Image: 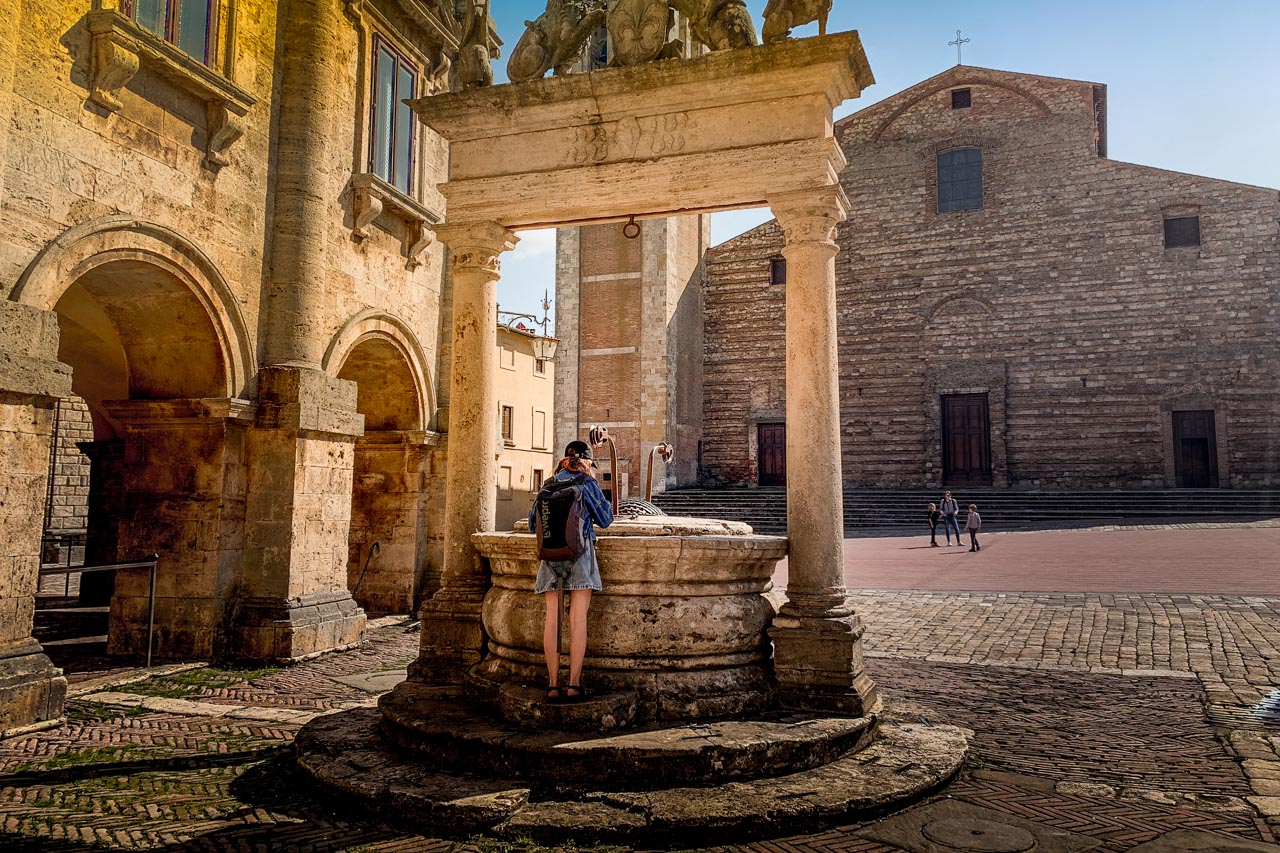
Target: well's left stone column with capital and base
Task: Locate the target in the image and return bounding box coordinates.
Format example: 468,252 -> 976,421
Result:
410,222 -> 518,683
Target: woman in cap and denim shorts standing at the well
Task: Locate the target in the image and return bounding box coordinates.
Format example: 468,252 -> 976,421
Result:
529,441 -> 613,702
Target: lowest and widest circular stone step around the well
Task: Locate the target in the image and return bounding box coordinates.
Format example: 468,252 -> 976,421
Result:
294,699 -> 968,847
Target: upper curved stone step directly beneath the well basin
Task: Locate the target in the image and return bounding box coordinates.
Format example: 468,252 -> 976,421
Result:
379,681 -> 873,790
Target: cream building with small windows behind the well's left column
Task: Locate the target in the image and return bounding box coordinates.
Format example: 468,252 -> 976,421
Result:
494,324 -> 559,530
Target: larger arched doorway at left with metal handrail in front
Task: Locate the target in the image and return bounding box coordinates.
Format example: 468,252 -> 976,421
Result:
13,219 -> 252,657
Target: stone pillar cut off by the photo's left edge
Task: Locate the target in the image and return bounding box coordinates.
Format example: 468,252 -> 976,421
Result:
0,298 -> 72,736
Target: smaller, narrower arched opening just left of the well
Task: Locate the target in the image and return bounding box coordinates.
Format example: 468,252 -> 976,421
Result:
338,333 -> 426,613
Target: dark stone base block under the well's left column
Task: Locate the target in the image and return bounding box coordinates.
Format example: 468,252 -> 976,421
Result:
408,593 -> 489,684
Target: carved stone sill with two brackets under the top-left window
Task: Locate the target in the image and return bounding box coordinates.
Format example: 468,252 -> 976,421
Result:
84,9 -> 257,172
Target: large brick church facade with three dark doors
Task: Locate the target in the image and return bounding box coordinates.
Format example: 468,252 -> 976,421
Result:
701,67 -> 1280,488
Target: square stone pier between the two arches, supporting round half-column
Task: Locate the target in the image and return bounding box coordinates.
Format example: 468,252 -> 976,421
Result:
235,368 -> 365,660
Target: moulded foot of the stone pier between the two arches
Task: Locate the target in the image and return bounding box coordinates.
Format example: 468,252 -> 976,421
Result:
228,590 -> 366,661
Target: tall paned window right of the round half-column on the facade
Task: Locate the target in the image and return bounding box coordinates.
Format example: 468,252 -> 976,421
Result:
369,35 -> 417,193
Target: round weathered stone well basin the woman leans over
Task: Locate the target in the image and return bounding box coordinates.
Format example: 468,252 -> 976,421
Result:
467,516 -> 787,722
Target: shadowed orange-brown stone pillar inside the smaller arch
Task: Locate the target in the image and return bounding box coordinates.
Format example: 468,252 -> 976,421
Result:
347,429 -> 434,613
